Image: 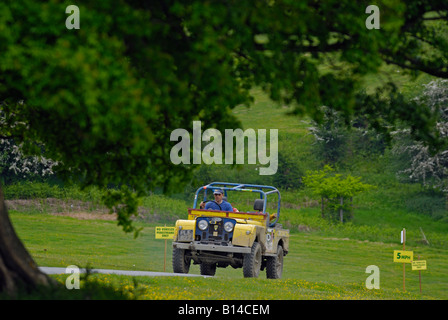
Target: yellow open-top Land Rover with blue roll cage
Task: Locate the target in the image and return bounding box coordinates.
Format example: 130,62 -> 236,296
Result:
173,182 -> 289,279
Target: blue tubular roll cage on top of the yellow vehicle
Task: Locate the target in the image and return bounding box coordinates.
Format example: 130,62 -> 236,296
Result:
193,182 -> 281,227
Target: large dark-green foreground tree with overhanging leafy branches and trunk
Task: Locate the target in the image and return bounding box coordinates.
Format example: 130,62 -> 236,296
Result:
0,0 -> 448,291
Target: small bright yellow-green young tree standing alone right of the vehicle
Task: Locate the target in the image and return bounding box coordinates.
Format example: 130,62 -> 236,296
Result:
303,165 -> 373,223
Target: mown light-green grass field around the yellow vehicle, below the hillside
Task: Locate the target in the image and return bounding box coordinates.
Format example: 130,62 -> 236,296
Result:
7,212 -> 448,300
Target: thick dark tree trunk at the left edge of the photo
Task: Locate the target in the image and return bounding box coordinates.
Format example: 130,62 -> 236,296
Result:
0,185 -> 51,295
